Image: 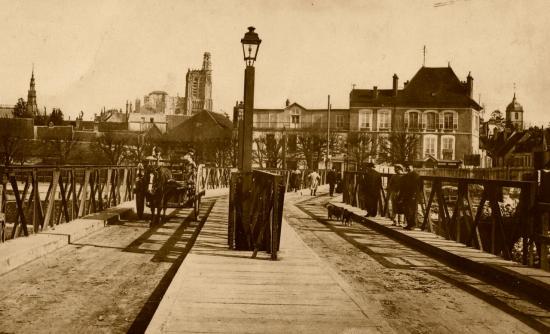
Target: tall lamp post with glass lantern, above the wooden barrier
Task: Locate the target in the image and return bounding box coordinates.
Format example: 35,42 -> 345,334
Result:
238,27 -> 262,173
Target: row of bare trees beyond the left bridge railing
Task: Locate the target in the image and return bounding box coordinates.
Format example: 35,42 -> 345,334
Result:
0,131 -> 234,167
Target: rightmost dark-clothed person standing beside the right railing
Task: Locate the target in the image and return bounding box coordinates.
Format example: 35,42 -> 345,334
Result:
399,164 -> 421,230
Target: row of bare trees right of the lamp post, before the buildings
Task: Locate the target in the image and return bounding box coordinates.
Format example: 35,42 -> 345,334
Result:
253,130 -> 419,169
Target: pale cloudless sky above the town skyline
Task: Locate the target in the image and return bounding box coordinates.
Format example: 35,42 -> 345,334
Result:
0,0 -> 550,125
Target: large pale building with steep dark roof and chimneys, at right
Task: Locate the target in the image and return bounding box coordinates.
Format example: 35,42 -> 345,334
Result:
349,67 -> 482,161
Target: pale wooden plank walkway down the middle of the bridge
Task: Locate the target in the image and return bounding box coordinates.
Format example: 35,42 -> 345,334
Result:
147,192 -> 391,333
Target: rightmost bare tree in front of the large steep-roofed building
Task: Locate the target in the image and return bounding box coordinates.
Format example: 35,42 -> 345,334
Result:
378,131 -> 418,164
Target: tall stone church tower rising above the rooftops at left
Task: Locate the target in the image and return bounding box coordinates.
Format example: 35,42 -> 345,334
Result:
183,52 -> 212,116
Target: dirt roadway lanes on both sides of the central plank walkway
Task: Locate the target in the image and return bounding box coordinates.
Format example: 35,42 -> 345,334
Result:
0,189 -> 550,333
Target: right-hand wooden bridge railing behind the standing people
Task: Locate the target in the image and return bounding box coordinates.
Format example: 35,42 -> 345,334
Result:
343,172 -> 548,265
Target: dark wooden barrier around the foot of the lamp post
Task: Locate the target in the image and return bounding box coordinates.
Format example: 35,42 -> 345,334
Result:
231,170 -> 285,260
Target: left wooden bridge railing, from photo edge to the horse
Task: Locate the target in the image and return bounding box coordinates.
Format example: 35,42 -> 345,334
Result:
0,166 -> 136,241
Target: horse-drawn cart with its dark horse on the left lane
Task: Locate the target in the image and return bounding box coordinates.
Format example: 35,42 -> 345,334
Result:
134,161 -> 205,225
